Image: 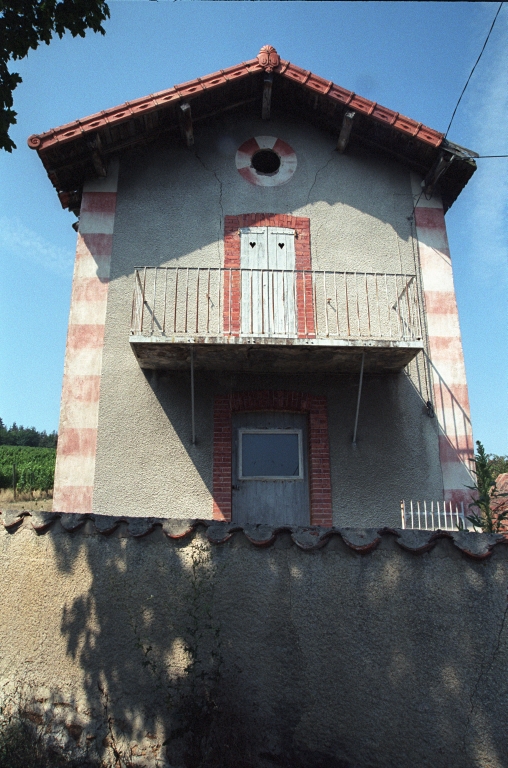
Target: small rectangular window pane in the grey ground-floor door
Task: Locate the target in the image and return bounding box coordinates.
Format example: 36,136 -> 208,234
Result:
238,429 -> 303,480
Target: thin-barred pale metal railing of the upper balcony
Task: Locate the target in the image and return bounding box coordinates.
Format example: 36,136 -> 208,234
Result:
131,267 -> 422,341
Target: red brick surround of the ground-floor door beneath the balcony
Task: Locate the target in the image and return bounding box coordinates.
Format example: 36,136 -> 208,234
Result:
213,390 -> 332,528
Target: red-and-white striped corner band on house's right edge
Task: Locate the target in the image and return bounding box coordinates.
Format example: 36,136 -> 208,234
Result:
412,174 -> 474,502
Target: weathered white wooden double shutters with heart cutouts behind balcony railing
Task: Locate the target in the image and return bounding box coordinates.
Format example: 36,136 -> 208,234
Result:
240,227 -> 296,336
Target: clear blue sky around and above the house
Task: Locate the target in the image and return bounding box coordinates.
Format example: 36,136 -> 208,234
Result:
0,0 -> 508,454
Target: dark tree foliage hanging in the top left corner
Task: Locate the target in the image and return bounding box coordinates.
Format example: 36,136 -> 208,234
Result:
0,0 -> 109,152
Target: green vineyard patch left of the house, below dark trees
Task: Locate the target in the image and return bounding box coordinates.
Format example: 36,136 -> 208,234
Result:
0,445 -> 56,492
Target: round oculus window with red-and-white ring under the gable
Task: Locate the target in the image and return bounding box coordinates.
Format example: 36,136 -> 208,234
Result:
236,136 -> 296,187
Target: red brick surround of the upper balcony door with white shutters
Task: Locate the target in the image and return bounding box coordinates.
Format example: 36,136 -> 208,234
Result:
223,213 -> 316,338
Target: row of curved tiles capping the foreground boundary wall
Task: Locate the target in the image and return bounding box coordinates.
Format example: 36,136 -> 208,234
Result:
0,511 -> 508,560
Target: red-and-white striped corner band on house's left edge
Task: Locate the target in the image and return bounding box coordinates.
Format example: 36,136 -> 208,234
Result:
53,161 -> 118,512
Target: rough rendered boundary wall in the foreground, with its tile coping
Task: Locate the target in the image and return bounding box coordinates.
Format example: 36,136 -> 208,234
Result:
0,513 -> 508,768
